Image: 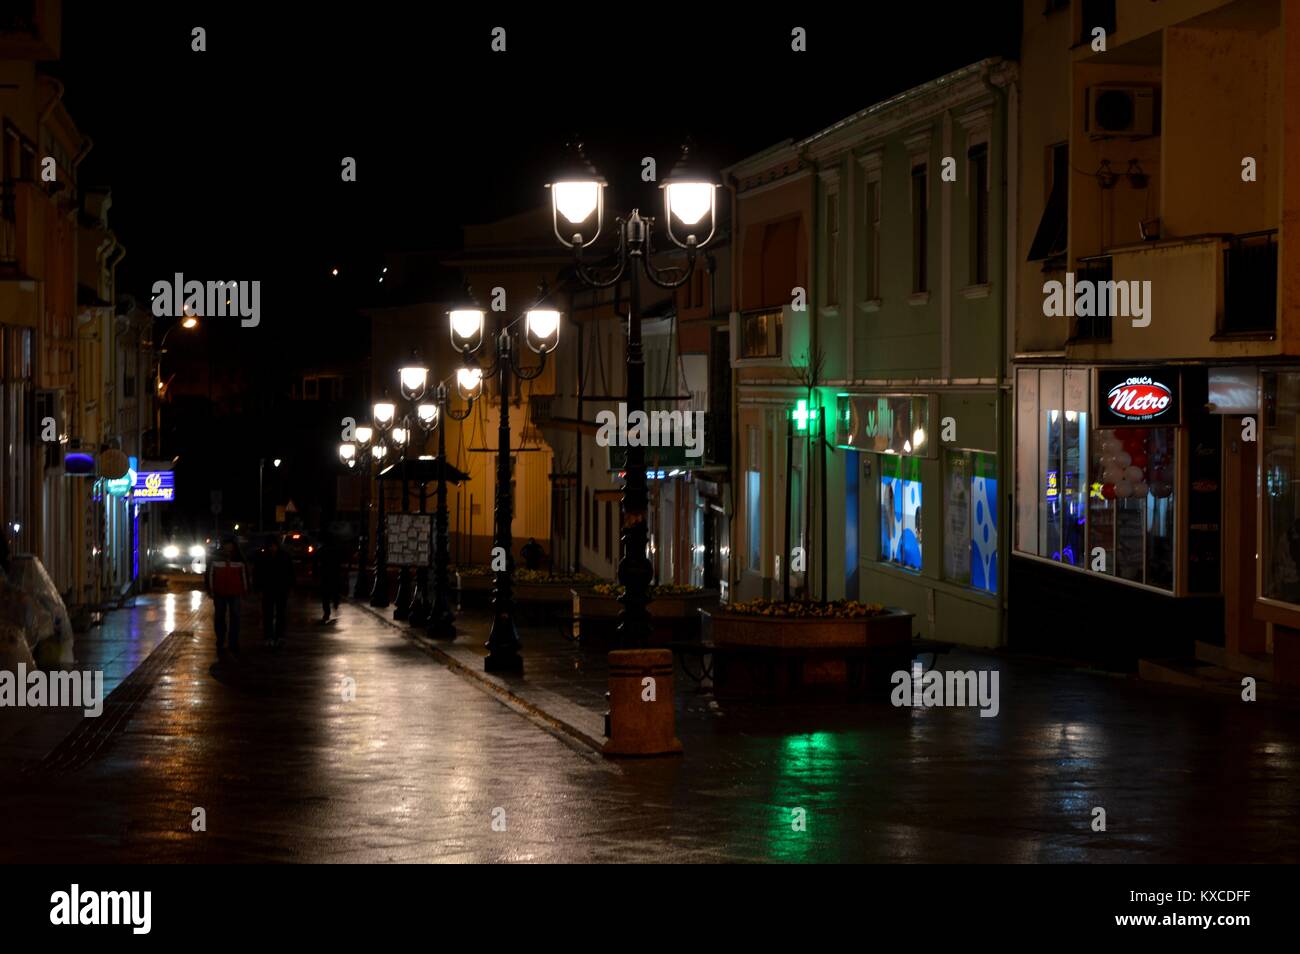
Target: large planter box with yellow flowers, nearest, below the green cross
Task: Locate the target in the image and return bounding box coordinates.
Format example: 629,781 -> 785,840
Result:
709,610 -> 913,702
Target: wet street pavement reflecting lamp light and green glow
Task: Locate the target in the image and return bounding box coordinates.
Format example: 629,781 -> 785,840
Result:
0,582 -> 1300,862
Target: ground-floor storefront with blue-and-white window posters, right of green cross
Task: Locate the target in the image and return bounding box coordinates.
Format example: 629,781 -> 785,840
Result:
832,387 -> 1006,646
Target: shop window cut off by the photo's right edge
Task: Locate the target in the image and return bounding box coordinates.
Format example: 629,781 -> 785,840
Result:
1261,372 -> 1300,603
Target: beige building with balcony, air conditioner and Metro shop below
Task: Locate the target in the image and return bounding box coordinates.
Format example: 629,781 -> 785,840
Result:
1010,0 -> 1300,681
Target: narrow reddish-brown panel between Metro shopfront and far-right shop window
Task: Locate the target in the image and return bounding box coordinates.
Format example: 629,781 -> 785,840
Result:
1223,415 -> 1265,652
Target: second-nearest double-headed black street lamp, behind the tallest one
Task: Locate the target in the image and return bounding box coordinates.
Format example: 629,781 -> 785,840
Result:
449,295 -> 560,673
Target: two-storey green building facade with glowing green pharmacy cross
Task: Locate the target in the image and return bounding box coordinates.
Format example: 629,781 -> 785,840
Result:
731,60 -> 1015,646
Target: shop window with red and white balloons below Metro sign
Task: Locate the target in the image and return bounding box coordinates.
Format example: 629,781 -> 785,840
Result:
1088,428 -> 1177,590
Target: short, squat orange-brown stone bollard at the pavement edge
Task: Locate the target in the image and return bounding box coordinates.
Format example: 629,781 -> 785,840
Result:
602,650 -> 681,755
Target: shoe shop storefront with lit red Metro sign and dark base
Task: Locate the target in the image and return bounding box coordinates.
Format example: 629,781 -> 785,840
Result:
1010,364 -> 1232,665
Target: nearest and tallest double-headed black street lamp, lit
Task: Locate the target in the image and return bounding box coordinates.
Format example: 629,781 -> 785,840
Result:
549,143 -> 719,646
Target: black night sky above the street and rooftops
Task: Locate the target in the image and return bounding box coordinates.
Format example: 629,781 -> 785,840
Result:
52,0 -> 1019,319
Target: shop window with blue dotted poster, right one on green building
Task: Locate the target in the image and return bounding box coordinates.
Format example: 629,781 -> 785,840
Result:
944,451 -> 997,593
